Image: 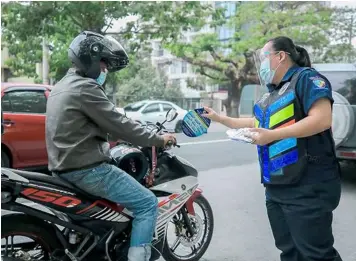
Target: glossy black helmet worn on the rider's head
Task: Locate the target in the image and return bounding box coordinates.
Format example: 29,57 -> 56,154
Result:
68,31 -> 129,79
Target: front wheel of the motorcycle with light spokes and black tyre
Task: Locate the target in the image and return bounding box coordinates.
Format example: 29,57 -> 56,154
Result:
162,195 -> 214,261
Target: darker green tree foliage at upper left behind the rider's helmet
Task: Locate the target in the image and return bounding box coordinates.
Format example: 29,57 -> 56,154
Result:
1,1 -> 209,80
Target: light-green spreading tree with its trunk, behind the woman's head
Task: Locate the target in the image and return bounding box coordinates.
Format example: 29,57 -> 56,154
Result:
165,2 -> 331,116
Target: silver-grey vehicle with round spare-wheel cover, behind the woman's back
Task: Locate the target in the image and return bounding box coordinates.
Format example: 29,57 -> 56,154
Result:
313,63 -> 356,163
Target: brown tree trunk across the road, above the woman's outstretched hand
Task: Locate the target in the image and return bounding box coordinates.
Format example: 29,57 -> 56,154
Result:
224,80 -> 242,118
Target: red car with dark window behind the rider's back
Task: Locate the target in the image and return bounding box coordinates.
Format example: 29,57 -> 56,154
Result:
1,83 -> 116,169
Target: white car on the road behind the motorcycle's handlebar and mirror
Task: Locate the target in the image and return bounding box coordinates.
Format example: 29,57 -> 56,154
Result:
116,100 -> 187,133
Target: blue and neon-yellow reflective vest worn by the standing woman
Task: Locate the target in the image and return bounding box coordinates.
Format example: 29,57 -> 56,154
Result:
254,68 -> 310,185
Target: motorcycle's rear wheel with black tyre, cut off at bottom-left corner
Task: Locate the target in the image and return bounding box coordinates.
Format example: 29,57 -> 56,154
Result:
1,213 -> 60,261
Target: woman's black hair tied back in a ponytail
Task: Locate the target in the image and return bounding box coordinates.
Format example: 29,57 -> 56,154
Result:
268,36 -> 311,67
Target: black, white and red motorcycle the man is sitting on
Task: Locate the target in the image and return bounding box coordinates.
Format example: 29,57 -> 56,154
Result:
1,109 -> 214,261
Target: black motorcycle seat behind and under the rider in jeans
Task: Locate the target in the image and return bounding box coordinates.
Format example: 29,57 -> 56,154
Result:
2,168 -> 100,199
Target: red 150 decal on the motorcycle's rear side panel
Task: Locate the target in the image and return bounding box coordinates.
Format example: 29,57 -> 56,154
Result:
21,188 -> 82,208
